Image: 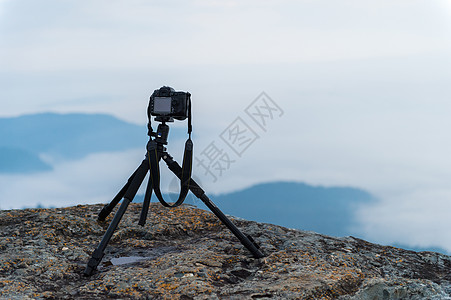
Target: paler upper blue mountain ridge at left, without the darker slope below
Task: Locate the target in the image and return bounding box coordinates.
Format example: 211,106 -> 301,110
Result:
0,113 -> 147,158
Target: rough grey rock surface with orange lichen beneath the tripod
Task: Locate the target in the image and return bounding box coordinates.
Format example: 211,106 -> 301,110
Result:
0,204 -> 451,299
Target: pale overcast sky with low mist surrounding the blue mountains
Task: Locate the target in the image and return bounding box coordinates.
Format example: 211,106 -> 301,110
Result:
0,0 -> 451,251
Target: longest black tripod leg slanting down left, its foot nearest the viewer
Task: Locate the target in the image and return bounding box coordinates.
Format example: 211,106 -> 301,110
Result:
84,160 -> 149,276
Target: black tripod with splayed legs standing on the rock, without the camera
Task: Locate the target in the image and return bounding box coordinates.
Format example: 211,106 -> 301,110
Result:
84,119 -> 264,276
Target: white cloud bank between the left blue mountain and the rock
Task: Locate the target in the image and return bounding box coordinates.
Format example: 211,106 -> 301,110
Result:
0,150 -> 144,209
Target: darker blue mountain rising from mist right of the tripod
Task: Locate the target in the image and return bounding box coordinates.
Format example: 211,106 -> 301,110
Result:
134,182 -> 375,236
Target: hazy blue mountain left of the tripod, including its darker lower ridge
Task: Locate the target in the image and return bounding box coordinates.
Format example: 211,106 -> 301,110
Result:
0,113 -> 182,173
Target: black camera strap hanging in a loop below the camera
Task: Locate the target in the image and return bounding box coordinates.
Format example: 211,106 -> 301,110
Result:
147,100 -> 193,207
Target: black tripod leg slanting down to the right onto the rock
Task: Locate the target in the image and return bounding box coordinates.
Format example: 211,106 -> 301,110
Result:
163,153 -> 265,258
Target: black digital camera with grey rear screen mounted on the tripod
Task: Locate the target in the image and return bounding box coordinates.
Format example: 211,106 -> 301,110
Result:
148,86 -> 191,120
